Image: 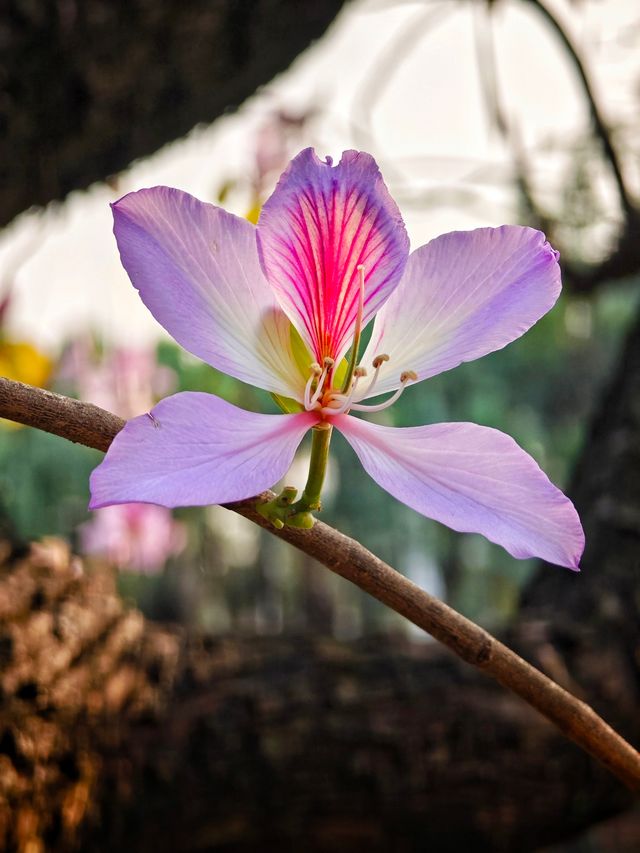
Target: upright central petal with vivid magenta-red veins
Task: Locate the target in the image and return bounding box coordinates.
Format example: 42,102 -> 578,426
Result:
258,148 -> 409,363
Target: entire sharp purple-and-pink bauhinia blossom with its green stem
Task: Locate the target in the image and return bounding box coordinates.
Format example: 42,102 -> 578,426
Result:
91,149 -> 584,569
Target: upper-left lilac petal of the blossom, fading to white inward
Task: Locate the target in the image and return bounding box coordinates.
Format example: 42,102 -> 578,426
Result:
112,187 -> 306,399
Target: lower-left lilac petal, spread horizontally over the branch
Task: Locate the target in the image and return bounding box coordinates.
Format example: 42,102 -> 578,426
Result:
89,391 -> 317,509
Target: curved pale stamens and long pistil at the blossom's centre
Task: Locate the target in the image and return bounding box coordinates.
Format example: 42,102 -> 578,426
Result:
304,266 -> 418,419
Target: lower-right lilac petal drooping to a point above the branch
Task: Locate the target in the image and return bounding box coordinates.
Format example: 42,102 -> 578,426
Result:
333,415 -> 584,570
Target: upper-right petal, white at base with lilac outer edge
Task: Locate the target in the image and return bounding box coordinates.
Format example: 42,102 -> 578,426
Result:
362,225 -> 561,395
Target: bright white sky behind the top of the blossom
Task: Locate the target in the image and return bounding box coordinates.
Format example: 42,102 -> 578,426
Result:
0,0 -> 640,351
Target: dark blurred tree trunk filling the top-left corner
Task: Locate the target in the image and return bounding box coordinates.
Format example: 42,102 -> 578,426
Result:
0,0 -> 343,227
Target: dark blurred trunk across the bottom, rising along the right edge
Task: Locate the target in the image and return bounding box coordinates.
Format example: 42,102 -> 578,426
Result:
0,308 -> 640,853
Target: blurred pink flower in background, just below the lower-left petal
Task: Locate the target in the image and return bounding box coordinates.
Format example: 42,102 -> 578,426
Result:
79,504 -> 187,574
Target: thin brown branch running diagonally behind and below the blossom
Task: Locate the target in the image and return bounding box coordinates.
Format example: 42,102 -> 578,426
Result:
0,379 -> 640,791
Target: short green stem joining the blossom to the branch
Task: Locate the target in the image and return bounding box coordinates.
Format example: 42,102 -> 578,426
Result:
256,421 -> 333,530
